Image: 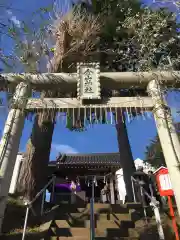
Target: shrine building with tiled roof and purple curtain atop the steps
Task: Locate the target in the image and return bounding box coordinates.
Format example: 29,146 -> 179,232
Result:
48,153 -> 121,204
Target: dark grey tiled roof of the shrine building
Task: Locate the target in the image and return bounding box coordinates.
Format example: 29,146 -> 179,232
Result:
57,153 -> 120,167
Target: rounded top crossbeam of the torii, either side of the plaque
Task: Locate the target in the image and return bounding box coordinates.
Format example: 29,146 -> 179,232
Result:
0,71 -> 180,92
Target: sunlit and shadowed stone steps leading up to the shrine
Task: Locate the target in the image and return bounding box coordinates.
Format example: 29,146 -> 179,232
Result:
41,203 -> 148,240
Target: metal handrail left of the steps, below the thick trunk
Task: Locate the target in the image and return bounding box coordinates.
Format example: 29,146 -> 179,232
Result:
22,175 -> 56,240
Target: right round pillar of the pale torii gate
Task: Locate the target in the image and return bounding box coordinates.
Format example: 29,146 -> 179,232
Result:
147,80 -> 180,215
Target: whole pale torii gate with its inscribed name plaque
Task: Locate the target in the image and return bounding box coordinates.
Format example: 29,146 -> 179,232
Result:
0,63 -> 180,231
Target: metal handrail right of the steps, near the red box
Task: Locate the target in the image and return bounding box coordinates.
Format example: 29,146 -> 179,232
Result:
131,176 -> 165,240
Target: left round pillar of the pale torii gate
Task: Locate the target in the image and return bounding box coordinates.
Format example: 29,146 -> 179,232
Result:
0,82 -> 30,232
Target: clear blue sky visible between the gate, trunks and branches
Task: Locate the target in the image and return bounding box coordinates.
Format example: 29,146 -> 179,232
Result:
0,0 -> 180,160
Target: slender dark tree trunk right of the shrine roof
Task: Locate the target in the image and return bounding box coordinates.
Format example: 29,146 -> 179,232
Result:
116,109 -> 136,202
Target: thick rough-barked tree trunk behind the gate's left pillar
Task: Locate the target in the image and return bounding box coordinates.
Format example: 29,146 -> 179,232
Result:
18,112 -> 55,201
